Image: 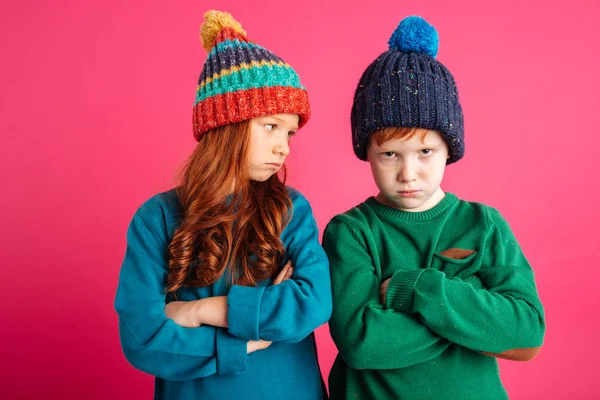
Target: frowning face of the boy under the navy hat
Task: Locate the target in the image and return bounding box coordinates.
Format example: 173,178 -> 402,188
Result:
367,129 -> 448,211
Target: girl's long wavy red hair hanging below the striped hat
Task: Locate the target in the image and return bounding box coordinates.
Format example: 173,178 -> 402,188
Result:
167,121 -> 292,293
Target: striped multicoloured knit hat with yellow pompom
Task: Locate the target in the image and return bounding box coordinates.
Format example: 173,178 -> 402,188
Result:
193,11 -> 310,140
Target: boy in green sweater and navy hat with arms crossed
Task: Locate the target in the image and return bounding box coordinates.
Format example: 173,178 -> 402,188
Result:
323,17 -> 545,400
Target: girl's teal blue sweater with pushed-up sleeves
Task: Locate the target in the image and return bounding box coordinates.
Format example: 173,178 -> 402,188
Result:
115,189 -> 331,400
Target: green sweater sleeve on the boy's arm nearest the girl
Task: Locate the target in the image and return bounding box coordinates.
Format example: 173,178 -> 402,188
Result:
323,218 -> 449,369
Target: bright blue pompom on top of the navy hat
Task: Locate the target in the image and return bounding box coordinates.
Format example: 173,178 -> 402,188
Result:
388,16 -> 440,58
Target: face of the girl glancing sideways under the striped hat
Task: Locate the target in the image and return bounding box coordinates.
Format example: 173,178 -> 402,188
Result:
248,114 -> 299,182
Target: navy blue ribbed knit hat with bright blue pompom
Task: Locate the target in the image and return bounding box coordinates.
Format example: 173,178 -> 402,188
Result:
351,16 -> 465,164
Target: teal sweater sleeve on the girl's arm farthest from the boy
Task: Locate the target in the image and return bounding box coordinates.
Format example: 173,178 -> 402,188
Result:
115,199 -> 247,380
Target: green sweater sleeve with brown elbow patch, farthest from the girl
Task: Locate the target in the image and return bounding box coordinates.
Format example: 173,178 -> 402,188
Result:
387,209 -> 545,360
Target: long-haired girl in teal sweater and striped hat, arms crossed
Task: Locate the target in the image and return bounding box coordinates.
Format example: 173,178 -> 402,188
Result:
115,11 -> 331,400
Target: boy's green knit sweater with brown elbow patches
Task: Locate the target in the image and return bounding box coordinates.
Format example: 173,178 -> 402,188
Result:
323,193 -> 545,400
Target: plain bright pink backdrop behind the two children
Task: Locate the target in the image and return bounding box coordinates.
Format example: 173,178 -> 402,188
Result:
0,0 -> 600,400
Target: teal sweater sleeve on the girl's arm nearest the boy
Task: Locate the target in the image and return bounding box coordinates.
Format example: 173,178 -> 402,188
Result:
227,192 -> 331,343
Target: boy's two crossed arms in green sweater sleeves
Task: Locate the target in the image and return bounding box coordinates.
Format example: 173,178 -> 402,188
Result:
323,217 -> 545,369
